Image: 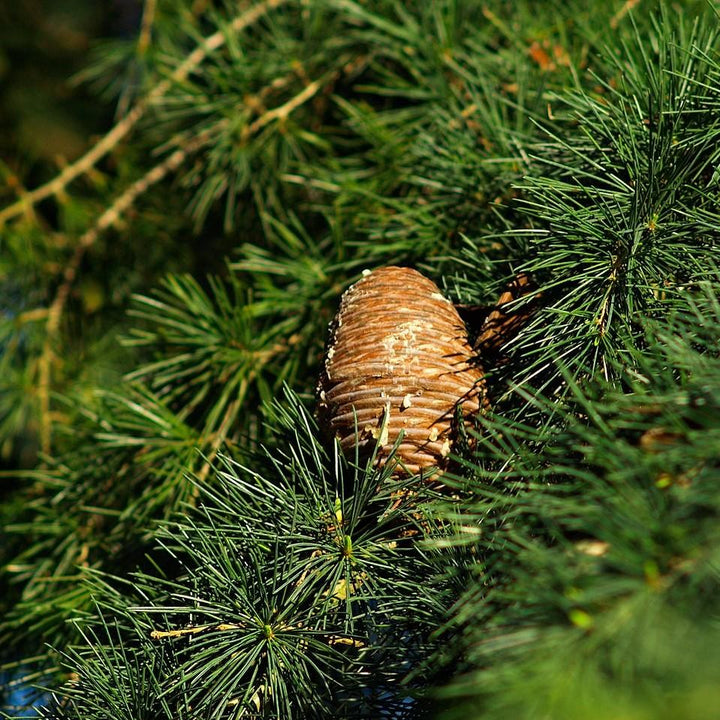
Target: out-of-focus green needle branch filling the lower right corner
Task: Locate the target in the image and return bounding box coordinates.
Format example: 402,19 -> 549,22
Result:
434,281 -> 720,719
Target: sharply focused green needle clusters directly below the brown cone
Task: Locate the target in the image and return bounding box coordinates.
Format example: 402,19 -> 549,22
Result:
35,396 -> 456,718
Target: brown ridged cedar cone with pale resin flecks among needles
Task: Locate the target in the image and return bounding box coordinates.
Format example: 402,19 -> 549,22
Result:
318,267 -> 486,474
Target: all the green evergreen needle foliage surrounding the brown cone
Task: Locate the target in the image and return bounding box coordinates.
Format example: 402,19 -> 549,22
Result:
0,0 -> 720,720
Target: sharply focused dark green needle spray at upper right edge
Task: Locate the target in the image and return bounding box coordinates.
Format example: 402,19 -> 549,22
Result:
500,8 -> 720,386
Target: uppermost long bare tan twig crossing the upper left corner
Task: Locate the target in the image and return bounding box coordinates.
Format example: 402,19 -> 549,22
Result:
0,0 -> 288,226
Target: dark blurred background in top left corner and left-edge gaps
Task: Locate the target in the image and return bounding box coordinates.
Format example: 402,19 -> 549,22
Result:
0,0 -> 132,716
